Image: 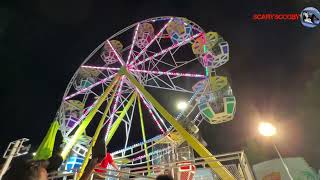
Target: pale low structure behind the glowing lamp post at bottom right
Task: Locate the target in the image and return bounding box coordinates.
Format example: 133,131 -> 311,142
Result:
253,157 -> 320,180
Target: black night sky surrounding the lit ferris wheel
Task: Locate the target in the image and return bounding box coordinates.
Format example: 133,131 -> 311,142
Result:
0,0 -> 320,168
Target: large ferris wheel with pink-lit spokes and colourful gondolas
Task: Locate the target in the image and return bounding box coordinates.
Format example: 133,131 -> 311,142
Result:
50,17 -> 236,179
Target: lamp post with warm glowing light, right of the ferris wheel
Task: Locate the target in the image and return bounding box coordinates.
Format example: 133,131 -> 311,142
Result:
259,122 -> 293,180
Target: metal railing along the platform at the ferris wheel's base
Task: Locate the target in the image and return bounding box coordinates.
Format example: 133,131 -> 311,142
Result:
49,151 -> 254,180
